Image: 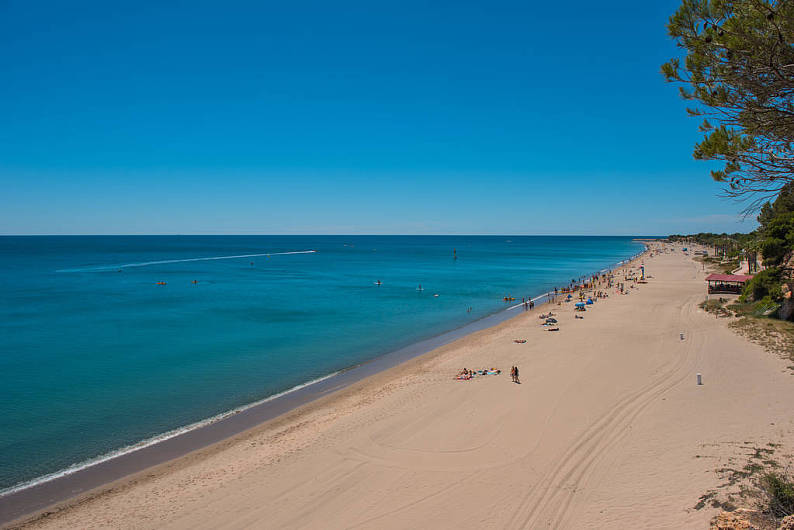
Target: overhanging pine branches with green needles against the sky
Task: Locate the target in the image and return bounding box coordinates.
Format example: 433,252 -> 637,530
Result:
662,0 -> 794,204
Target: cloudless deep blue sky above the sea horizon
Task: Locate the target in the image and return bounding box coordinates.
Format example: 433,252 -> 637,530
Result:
0,0 -> 756,235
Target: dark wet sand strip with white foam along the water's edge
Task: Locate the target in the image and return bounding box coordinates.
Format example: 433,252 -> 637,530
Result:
0,245 -> 657,527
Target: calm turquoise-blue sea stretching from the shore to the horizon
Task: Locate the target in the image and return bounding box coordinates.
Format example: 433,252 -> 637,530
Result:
0,236 -> 643,490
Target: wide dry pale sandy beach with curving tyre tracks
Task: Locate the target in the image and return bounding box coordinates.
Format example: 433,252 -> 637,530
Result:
6,244 -> 794,528
